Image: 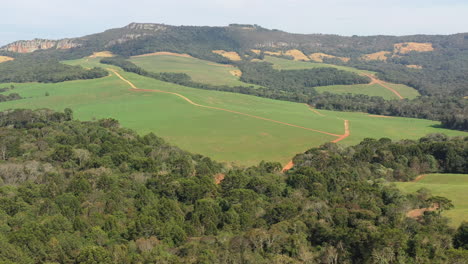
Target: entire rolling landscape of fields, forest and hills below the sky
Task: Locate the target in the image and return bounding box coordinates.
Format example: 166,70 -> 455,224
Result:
0,23 -> 468,264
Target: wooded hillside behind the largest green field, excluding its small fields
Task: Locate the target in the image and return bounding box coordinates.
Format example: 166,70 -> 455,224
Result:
0,23 -> 468,130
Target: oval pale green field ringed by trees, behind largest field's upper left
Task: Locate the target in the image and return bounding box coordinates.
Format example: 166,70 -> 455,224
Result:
130,55 -> 253,87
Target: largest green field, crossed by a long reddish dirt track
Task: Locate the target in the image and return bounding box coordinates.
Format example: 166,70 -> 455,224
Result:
0,59 -> 468,165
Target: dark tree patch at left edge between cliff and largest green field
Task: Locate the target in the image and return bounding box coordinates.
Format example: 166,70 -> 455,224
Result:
0,56 -> 107,83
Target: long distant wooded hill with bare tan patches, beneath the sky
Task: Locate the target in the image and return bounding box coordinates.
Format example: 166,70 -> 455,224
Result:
0,23 -> 468,96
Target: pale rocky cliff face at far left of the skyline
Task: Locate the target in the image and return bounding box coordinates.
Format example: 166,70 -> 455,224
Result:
0,39 -> 80,53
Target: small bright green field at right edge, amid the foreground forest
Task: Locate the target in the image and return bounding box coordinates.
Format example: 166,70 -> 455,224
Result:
396,174 -> 468,227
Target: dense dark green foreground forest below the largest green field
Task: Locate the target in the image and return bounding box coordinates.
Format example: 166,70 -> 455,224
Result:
0,109 -> 468,263
